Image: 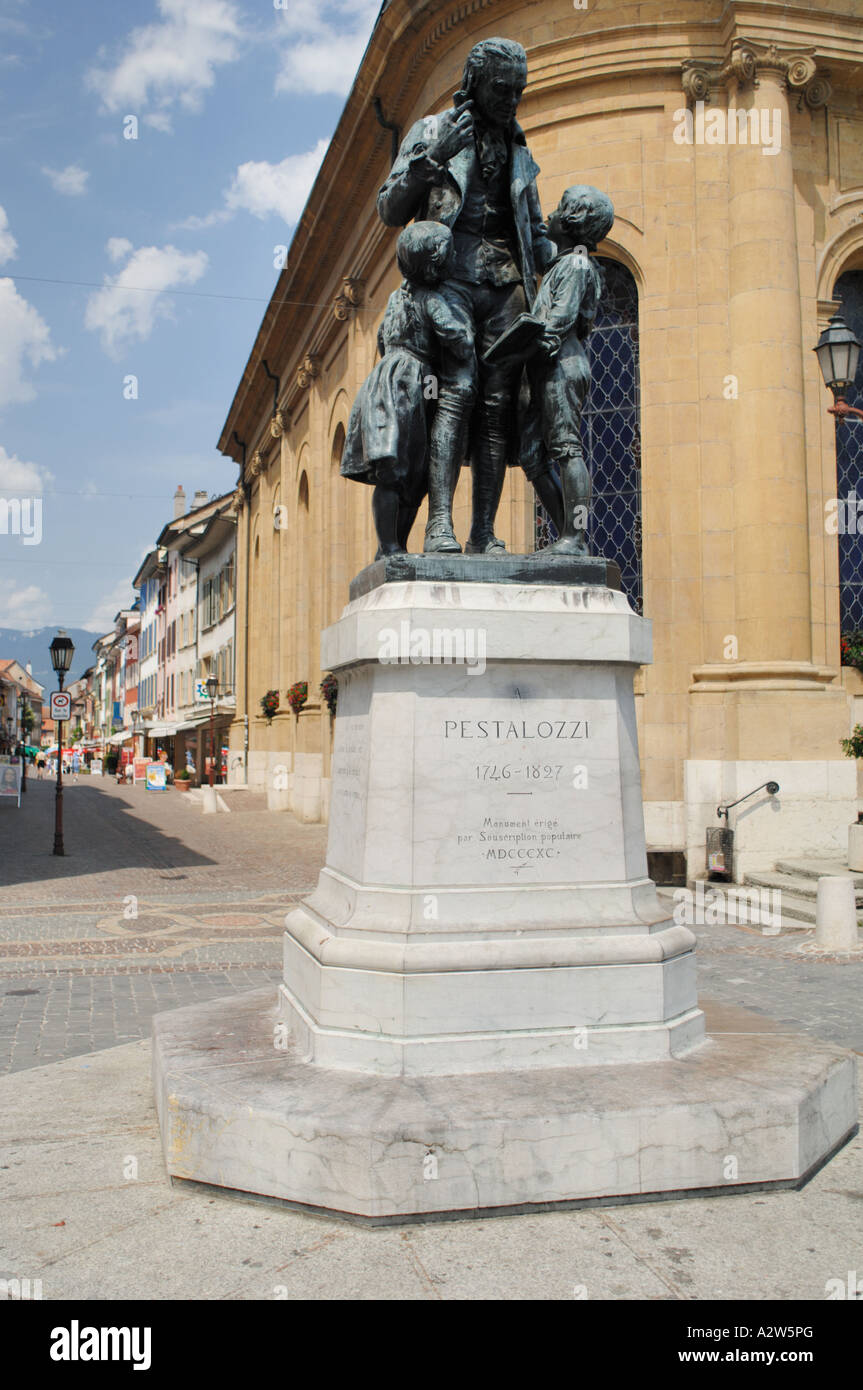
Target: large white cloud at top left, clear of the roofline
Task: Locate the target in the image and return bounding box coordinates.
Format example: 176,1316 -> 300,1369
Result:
86,0 -> 242,129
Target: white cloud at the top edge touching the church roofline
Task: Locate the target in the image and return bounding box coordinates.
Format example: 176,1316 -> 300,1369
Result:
275,0 -> 381,96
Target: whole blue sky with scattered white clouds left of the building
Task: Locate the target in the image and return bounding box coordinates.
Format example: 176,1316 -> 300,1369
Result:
0,0 -> 381,636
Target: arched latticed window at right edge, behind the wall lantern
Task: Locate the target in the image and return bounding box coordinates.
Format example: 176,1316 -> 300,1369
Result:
832,270 -> 863,635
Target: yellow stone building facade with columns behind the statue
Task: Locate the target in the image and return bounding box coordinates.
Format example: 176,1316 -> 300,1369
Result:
220,0 -> 863,873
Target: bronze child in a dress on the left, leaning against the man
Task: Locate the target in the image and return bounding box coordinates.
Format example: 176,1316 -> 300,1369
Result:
340,222 -> 475,555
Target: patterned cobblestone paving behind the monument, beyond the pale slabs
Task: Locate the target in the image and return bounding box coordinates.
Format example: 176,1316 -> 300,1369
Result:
0,778 -> 863,1072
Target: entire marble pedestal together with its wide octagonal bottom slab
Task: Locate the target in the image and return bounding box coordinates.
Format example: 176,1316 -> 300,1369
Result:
154,557 -> 856,1220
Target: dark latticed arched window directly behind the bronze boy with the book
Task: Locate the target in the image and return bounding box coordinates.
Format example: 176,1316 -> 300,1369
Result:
536,256 -> 643,613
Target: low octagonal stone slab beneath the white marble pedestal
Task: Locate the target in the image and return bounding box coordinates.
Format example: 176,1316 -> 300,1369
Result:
153,990 -> 856,1223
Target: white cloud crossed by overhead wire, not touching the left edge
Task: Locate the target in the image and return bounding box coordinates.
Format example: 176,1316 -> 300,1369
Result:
83,236 -> 208,357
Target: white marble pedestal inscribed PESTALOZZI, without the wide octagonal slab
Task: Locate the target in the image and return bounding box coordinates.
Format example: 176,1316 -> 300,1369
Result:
281,575 -> 705,1076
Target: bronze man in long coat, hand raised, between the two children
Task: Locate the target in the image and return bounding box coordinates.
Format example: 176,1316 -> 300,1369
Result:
378,39 -> 554,555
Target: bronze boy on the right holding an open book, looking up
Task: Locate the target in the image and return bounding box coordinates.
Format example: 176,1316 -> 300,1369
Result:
520,185 -> 614,555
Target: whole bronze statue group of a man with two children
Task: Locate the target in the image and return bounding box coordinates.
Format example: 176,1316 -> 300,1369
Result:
342,39 -> 614,557
